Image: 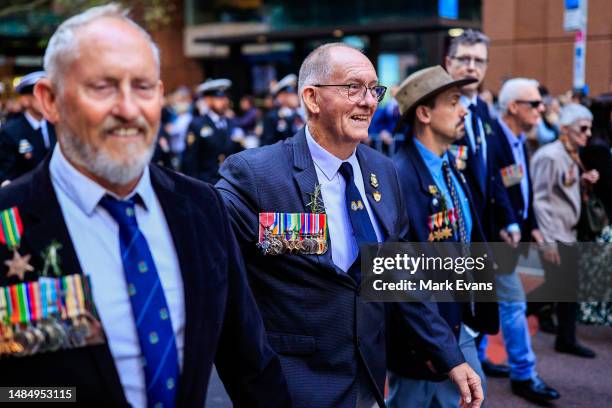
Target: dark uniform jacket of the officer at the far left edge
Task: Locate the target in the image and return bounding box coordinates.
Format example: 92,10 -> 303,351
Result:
0,114 -> 55,182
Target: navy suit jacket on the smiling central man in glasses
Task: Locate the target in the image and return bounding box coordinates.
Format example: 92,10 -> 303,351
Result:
217,130 -> 464,408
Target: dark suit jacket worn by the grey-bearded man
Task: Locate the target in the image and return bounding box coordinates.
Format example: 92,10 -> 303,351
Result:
0,160 -> 290,407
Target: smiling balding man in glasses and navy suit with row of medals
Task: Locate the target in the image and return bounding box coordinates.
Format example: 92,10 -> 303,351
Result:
217,43 -> 482,408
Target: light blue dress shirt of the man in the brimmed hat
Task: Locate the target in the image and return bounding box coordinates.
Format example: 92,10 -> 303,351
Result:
414,138 -> 472,242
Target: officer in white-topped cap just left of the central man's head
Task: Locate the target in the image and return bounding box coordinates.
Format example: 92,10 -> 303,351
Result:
261,74 -> 304,146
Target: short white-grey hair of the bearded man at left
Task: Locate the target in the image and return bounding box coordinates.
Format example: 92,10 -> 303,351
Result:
44,3 -> 160,89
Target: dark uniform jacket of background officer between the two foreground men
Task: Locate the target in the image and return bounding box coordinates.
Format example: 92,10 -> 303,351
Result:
181,115 -> 242,184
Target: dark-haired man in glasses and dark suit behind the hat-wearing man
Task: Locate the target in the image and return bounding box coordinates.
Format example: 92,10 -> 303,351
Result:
446,29 -> 521,377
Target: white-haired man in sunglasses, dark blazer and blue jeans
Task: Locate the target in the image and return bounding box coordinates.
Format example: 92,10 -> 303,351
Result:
480,78 -> 559,403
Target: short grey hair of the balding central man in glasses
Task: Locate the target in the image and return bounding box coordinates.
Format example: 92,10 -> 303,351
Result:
298,42 -> 362,116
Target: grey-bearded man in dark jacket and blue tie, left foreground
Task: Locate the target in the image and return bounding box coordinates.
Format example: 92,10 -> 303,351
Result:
0,4 -> 290,407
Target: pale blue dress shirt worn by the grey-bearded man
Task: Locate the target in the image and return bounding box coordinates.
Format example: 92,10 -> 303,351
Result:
50,144 -> 185,407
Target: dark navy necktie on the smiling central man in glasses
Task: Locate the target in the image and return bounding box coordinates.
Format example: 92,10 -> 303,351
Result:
339,162 -> 378,284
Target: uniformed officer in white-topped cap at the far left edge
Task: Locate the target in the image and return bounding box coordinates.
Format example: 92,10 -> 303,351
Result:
0,71 -> 55,183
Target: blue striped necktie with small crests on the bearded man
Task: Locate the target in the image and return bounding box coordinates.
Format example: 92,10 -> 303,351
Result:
100,196 -> 179,408
